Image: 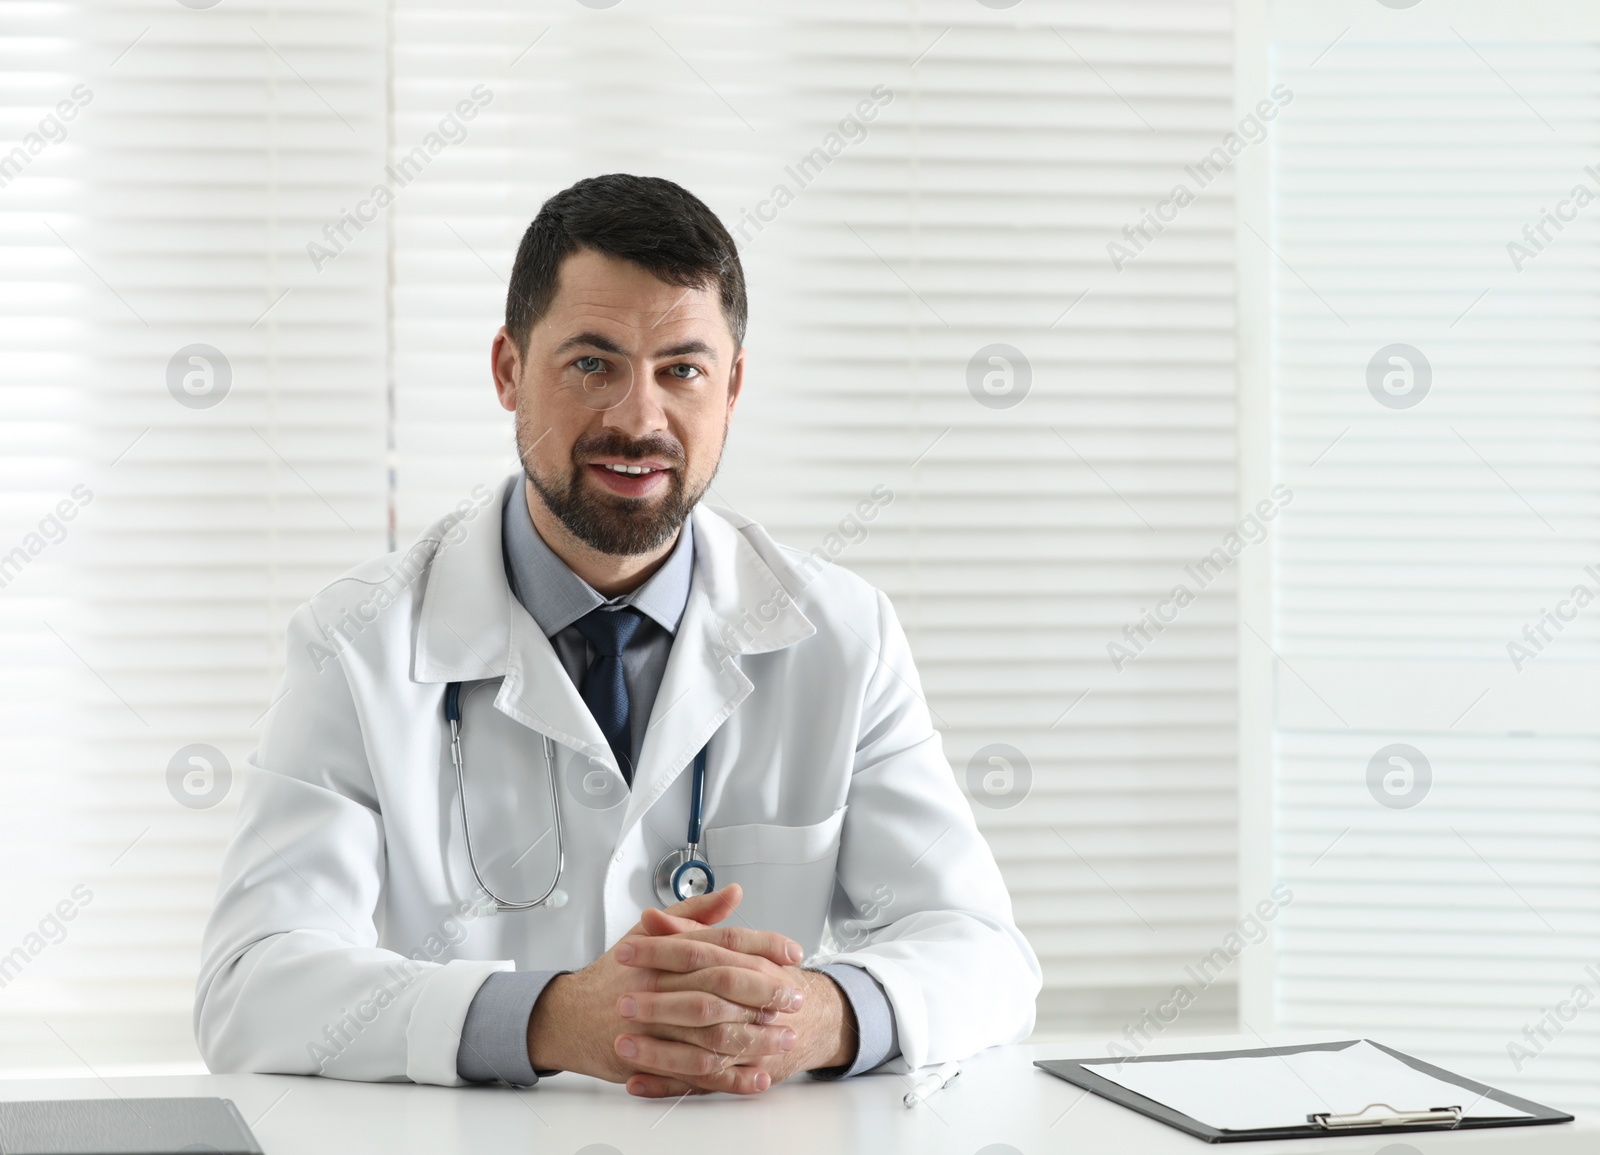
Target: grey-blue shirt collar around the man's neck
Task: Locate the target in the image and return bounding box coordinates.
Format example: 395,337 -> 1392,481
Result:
501,478 -> 694,638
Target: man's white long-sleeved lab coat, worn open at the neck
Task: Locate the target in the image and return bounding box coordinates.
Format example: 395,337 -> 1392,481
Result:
195,474 -> 1040,1085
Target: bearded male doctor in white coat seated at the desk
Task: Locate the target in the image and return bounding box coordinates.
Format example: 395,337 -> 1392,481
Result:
195,174 -> 1040,1096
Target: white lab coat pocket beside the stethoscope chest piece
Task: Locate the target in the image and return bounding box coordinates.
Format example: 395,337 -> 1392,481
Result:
706,806 -> 848,957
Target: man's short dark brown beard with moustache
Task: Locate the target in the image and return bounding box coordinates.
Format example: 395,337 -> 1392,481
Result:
517,419 -> 728,557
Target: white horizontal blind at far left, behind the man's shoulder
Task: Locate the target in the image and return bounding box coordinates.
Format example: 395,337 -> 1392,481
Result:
0,0 -> 386,1073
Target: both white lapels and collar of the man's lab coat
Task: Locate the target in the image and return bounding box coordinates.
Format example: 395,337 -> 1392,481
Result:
411,472 -> 816,796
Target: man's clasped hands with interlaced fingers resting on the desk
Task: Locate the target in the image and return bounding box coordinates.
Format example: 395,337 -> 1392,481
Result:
528,885 -> 854,1097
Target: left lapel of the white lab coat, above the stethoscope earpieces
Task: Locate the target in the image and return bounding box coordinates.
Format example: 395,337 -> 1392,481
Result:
406,474 -> 616,769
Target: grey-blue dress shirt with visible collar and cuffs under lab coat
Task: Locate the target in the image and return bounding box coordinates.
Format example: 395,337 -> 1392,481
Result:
456,482 -> 899,1086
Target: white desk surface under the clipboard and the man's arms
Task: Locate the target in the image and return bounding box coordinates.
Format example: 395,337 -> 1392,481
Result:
0,1038 -> 1600,1155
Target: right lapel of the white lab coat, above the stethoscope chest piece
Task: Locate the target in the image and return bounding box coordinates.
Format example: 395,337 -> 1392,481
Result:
622,507 -> 816,837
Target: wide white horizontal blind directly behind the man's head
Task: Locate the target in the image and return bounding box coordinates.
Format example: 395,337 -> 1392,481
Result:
395,0 -> 1237,1038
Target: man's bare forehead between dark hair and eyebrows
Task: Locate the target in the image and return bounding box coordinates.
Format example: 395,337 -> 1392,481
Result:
533,248 -> 733,344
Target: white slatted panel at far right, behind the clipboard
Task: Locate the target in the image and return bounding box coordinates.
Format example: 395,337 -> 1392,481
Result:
1258,15 -> 1600,1107
